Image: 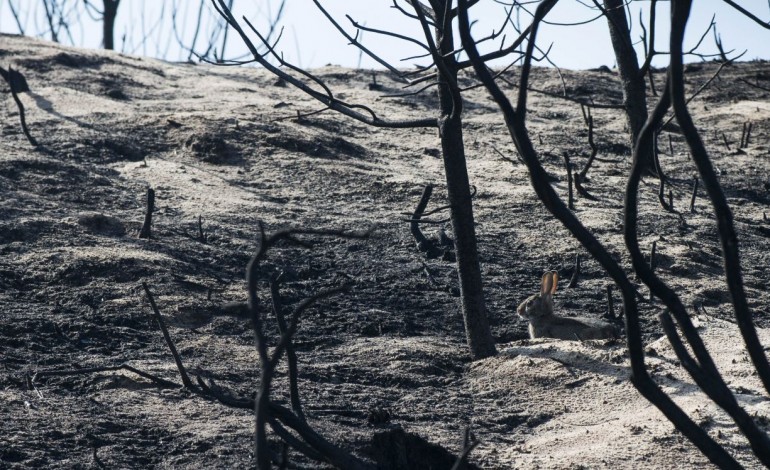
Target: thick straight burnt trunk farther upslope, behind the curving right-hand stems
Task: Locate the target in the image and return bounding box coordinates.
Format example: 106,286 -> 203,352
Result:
604,0 -> 647,154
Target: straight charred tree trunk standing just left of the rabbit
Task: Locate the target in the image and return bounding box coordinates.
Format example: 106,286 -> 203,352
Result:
431,0 -> 497,359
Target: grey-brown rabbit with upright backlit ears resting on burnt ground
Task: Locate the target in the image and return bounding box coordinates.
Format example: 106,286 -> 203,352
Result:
517,271 -> 618,341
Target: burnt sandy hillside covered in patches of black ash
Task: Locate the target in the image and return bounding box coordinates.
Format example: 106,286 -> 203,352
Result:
0,36 -> 770,469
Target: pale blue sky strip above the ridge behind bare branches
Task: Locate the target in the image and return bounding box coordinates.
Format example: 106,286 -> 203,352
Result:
0,0 -> 770,69
